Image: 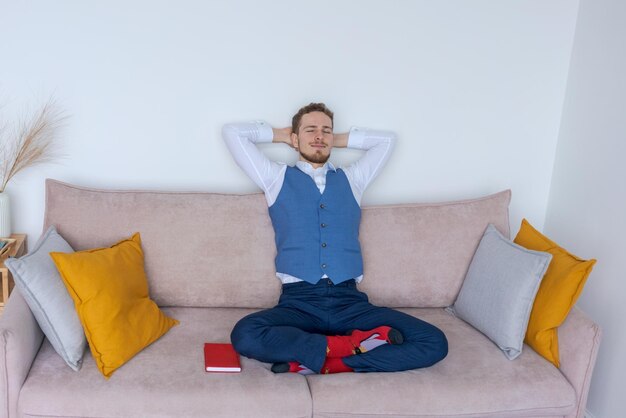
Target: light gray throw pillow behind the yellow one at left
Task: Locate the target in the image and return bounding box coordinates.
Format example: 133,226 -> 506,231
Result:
4,226 -> 87,371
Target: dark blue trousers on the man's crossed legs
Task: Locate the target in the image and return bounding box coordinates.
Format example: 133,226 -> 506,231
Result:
231,279 -> 448,373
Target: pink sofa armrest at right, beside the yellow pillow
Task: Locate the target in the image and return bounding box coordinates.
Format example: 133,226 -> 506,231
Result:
558,306 -> 602,418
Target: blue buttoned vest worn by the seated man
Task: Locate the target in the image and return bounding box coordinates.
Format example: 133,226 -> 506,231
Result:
269,167 -> 363,284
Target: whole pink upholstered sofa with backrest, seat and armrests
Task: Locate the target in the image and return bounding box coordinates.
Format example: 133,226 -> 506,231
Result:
0,180 -> 600,418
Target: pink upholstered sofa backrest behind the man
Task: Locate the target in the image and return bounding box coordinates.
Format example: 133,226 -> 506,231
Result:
44,180 -> 510,308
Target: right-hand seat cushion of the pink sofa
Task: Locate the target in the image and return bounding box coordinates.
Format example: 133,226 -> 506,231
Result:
307,309 -> 576,418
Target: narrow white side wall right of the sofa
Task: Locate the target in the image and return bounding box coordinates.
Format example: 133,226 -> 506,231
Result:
545,0 -> 626,418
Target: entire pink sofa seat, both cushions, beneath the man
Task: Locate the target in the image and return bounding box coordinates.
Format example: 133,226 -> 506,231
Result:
18,308 -> 576,418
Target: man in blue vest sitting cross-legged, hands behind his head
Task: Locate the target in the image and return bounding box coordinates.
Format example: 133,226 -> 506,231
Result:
222,103 -> 448,374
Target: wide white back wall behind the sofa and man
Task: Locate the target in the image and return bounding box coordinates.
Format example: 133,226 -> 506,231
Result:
0,0 -> 578,242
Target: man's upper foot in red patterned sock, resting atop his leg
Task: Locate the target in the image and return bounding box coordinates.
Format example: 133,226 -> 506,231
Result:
326,326 -> 404,358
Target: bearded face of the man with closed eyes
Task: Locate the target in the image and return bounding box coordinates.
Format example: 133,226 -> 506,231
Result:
291,112 -> 334,168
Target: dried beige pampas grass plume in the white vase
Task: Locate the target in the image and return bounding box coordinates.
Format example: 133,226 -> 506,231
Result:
0,99 -> 67,193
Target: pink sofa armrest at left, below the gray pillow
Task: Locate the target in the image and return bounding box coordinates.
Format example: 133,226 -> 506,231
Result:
0,291 -> 43,417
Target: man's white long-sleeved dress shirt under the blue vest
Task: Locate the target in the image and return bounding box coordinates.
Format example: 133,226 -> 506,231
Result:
222,121 -> 396,283
